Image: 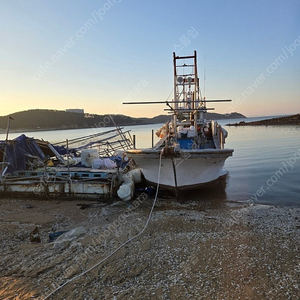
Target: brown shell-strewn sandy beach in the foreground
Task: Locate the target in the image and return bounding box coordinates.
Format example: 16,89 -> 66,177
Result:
0,197 -> 300,300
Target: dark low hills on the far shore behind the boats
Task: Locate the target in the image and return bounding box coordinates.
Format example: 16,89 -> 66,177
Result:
0,109 -> 245,131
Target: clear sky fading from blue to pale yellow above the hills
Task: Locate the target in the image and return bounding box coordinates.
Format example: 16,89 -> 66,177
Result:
0,0 -> 300,117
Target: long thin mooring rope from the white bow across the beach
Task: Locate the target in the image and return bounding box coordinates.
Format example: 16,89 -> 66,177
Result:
43,149 -> 163,300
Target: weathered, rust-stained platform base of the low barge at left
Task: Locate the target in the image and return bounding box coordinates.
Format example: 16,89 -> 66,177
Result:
0,167 -> 121,198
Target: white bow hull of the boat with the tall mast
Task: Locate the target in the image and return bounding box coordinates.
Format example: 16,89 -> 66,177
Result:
127,149 -> 233,188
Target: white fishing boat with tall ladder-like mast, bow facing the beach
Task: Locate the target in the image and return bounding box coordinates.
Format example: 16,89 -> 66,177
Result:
124,51 -> 234,192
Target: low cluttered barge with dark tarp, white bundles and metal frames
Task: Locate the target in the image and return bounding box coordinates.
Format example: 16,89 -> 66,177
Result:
0,126 -> 136,199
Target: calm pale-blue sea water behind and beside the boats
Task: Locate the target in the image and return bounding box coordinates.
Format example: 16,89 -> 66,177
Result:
0,117 -> 300,206
